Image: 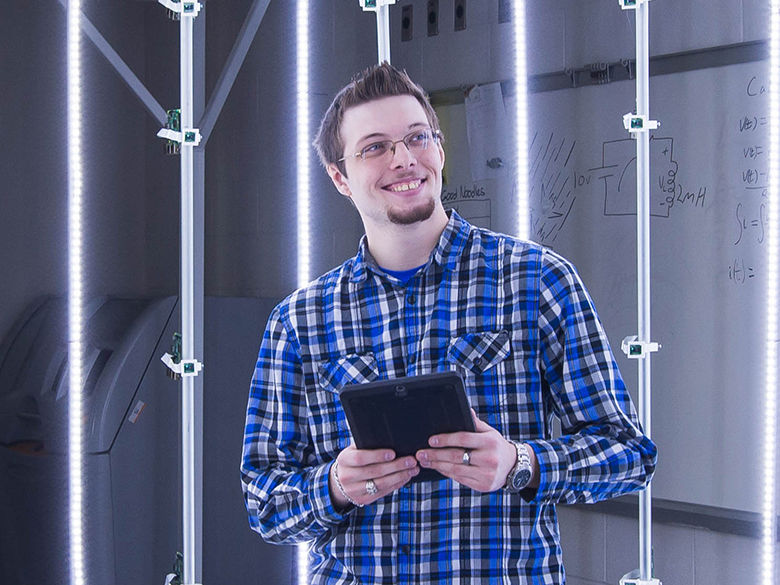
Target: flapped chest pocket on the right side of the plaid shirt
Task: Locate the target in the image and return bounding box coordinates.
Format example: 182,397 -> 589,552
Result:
447,330 -> 512,428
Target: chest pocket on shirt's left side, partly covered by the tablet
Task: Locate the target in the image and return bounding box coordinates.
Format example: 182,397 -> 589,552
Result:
314,353 -> 379,455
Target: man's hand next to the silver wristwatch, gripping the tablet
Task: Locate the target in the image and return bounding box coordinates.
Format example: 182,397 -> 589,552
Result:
415,409 -> 517,492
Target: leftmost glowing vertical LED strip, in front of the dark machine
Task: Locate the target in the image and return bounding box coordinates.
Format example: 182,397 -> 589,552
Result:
67,0 -> 86,585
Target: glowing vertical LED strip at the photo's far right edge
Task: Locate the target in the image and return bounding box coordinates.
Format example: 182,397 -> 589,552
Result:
761,0 -> 780,585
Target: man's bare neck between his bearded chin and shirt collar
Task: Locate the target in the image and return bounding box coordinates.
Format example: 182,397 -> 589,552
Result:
365,204 -> 449,270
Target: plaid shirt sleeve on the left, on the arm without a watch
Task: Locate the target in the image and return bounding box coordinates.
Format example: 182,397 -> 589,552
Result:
241,307 -> 345,544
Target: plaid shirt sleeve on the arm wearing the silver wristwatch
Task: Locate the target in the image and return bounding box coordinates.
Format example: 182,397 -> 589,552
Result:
529,251 -> 657,503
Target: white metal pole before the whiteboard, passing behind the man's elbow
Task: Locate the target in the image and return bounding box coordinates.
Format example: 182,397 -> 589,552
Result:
635,2 -> 653,581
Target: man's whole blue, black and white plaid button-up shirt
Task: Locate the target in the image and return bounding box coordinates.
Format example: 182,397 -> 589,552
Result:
241,211 -> 656,585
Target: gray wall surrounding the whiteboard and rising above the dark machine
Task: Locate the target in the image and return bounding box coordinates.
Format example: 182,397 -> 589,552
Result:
0,0 -> 768,585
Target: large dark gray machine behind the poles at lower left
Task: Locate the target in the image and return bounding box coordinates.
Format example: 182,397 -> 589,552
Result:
0,297 -> 294,585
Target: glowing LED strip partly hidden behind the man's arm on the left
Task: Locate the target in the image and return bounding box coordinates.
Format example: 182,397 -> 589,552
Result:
295,0 -> 311,585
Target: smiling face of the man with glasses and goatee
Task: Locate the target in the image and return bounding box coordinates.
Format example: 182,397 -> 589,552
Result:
328,95 -> 444,230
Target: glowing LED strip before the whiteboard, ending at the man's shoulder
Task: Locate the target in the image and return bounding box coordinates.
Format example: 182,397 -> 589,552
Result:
512,0 -> 530,239
